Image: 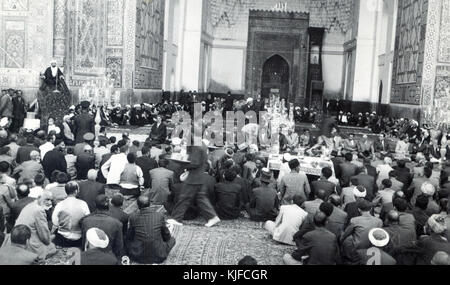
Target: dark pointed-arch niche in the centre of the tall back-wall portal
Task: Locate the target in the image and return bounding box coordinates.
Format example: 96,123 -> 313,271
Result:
261,54 -> 290,102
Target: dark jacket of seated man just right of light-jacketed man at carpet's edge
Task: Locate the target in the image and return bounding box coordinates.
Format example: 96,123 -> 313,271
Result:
292,228 -> 338,265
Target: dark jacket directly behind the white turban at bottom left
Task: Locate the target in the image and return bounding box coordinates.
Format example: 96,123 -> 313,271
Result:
81,211 -> 124,258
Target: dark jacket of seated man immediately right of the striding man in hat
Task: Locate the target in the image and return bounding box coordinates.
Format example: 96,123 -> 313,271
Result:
215,182 -> 241,220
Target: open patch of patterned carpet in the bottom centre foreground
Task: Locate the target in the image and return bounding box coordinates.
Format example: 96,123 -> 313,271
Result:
165,220 -> 294,265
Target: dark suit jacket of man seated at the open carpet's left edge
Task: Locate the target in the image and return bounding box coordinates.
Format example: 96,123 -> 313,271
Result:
127,205 -> 175,264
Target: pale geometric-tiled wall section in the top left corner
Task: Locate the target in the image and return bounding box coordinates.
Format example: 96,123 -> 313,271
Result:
0,0 -> 54,89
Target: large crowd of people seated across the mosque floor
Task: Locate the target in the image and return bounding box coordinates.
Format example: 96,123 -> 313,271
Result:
0,90 -> 450,265
